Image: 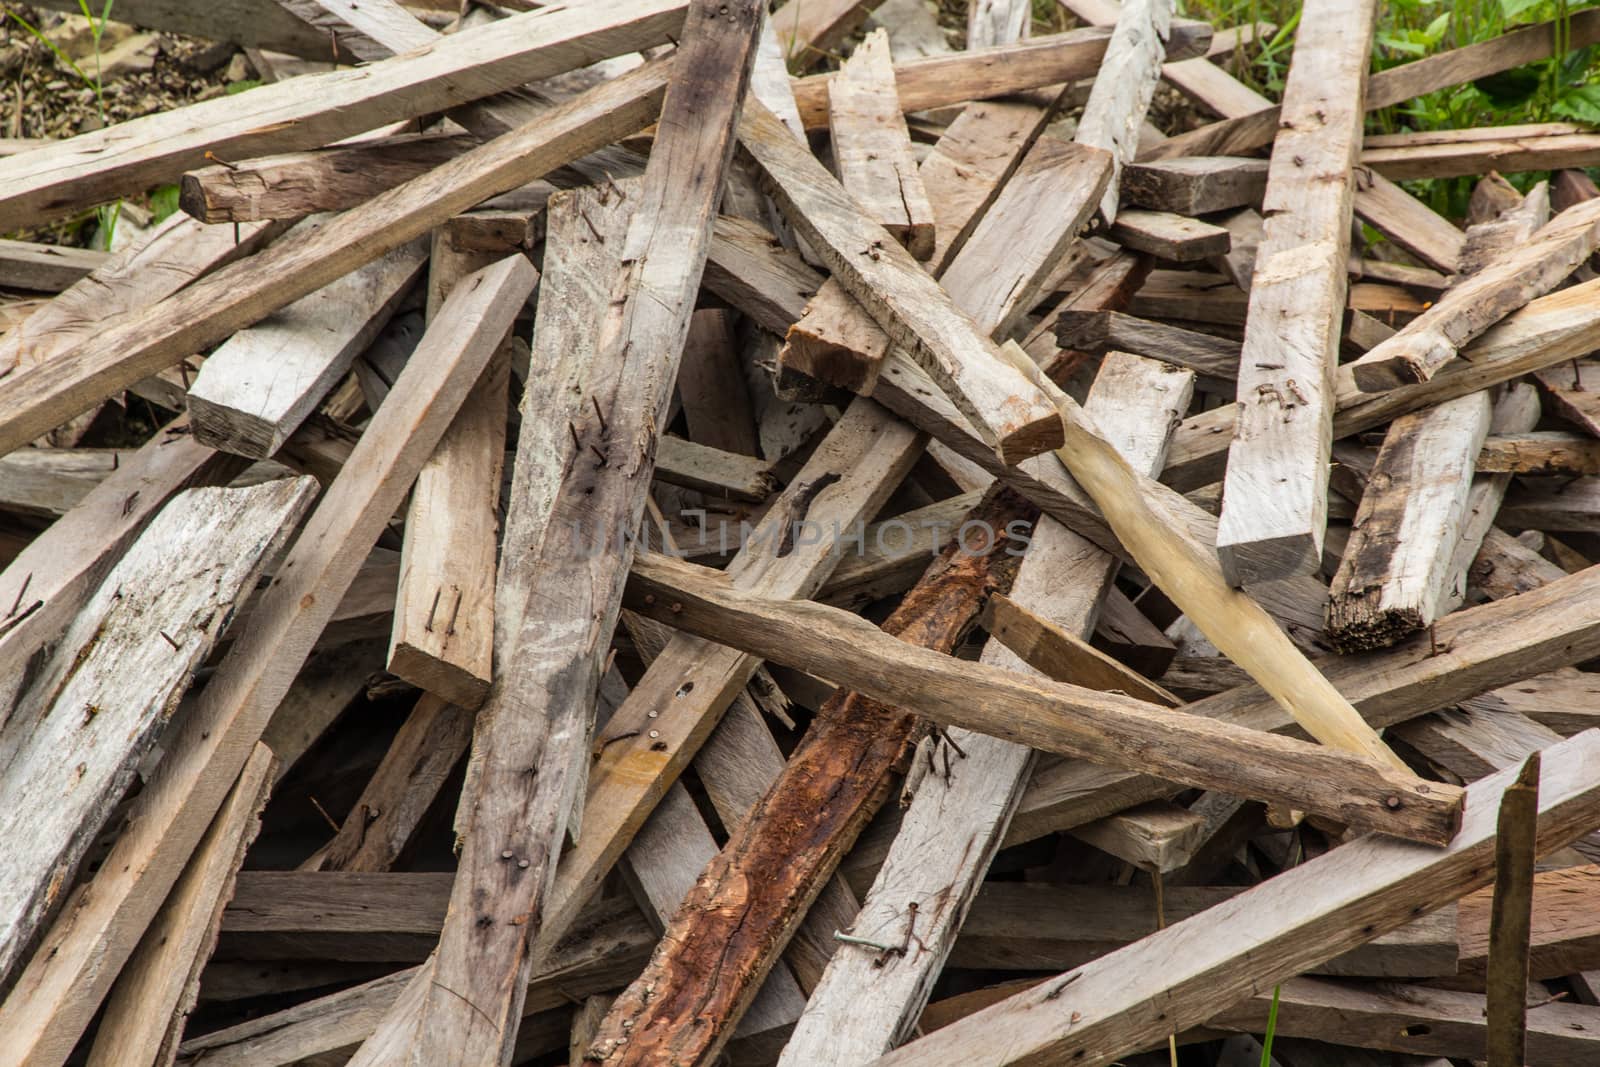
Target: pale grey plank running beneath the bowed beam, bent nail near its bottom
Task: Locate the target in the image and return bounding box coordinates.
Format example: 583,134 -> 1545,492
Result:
779,357 -> 1192,1067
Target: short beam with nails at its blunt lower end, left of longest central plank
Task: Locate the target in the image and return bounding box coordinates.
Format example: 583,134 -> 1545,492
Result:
389,232 -> 510,710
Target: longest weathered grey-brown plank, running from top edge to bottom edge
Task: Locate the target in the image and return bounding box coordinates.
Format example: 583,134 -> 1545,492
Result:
354,2 -> 758,1064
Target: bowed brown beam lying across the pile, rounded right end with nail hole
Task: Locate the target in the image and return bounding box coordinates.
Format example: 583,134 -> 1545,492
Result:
627,557 -> 1459,841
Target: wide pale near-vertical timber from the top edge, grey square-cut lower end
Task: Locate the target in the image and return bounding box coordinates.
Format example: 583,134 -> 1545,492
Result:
1216,0 -> 1376,585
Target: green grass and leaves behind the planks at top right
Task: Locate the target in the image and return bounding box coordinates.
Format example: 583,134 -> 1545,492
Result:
1176,0 -> 1600,218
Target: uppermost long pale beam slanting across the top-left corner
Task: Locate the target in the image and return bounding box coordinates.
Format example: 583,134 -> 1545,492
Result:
0,0 -> 686,230
